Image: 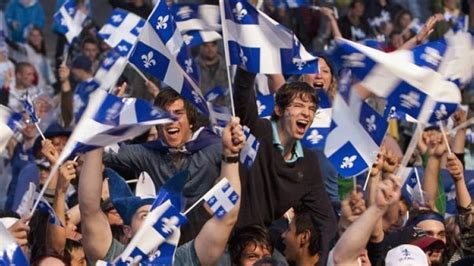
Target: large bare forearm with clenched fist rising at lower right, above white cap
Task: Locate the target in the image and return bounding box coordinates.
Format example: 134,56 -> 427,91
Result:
333,175 -> 400,265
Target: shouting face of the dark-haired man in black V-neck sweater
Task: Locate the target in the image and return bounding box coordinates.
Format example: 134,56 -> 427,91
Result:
275,94 -> 317,144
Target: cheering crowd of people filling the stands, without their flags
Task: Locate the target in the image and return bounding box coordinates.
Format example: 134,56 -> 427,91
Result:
0,0 -> 474,265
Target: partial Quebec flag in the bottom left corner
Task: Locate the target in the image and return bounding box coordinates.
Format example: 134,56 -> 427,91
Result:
0,223 -> 29,265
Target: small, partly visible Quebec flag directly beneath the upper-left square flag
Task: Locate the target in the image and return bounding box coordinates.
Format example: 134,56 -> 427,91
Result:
94,49 -> 127,90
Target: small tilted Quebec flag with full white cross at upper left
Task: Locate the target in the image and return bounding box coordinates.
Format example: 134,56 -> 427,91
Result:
97,8 -> 145,57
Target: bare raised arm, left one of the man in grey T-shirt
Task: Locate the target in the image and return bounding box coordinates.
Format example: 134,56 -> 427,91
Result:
79,149 -> 112,261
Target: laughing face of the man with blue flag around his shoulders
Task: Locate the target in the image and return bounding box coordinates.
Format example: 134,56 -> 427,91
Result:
158,99 -> 193,148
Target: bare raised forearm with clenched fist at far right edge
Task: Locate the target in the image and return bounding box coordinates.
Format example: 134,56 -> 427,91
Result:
446,154 -> 471,208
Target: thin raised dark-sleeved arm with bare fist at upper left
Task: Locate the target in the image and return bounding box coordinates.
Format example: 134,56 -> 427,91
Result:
58,65 -> 74,127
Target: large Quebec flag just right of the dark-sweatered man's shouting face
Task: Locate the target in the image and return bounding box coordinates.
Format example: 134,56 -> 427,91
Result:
324,70 -> 388,177
